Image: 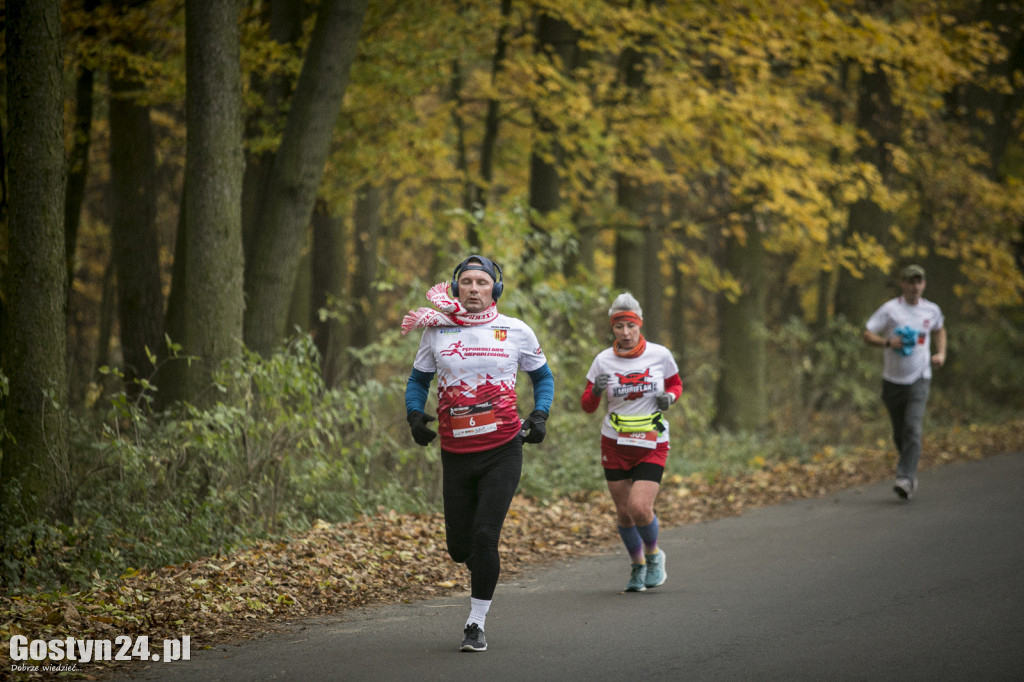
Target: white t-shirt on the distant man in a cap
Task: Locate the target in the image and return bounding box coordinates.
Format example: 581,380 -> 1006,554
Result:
866,296 -> 943,386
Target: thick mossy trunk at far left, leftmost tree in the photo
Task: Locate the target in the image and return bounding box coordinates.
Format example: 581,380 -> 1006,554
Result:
0,0 -> 72,528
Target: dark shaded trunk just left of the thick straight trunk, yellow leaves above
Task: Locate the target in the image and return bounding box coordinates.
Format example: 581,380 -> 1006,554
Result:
110,77 -> 164,393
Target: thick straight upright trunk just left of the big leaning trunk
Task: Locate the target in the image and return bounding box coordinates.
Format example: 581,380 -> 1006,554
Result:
182,0 -> 244,404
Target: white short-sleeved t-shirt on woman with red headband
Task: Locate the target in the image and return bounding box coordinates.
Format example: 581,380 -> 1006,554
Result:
587,341 -> 679,442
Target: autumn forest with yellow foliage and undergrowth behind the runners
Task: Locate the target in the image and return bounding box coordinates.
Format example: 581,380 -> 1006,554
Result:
0,0 -> 1024,584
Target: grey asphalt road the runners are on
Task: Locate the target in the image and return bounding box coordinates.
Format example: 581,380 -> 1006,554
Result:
126,454 -> 1024,682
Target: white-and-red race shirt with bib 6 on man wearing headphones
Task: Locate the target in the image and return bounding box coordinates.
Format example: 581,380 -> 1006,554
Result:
413,314 -> 547,453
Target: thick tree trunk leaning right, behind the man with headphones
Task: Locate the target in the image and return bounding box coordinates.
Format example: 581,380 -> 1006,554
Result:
245,0 -> 368,355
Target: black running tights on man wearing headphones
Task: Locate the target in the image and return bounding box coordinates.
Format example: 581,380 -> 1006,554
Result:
441,436 -> 522,600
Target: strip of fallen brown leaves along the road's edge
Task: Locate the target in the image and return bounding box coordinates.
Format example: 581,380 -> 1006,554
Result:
0,419 -> 1024,679
